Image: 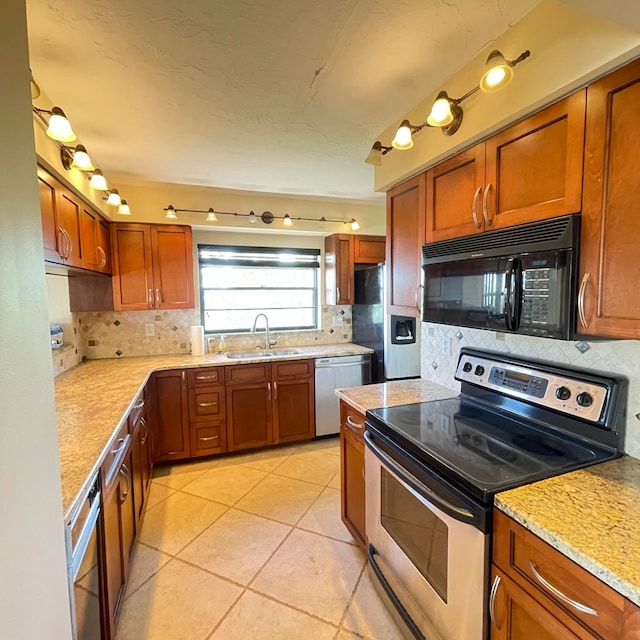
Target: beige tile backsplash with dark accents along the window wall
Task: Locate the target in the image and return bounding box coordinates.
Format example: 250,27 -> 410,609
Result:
77,306 -> 351,360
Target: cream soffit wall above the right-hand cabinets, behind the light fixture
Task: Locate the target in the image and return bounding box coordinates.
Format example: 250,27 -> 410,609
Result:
371,0 -> 640,191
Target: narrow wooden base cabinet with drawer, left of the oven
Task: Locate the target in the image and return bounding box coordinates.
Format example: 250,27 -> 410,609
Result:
340,400 -> 367,547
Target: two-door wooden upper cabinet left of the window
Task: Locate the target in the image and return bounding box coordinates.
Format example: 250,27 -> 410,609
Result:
111,224 -> 194,311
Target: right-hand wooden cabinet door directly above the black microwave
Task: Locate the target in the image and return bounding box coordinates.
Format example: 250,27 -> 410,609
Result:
482,90 -> 585,230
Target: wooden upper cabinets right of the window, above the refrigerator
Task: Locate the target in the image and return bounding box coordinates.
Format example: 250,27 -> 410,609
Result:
324,234 -> 386,305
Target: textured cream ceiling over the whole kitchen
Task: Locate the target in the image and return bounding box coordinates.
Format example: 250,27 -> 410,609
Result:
26,0 -> 537,201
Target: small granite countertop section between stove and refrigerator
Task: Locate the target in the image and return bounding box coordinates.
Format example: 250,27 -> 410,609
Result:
336,379 -> 459,414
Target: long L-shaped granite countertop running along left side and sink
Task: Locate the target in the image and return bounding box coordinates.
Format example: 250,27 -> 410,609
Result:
55,343 -> 372,521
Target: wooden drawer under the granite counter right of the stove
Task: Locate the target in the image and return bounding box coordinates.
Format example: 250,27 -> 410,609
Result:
493,511 -> 625,638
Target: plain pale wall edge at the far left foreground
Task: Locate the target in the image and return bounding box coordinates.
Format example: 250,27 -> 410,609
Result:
0,0 -> 71,640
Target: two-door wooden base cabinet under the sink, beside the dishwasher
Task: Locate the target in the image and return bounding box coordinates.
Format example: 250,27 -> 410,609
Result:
226,360 -> 315,451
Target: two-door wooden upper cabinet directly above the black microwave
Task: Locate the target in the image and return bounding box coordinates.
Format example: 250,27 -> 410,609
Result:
426,90 -> 585,242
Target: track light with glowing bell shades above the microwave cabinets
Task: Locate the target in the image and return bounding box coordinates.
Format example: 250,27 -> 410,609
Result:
365,49 -> 531,167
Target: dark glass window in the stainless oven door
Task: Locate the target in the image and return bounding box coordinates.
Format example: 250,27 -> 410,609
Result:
380,468 -> 449,602
